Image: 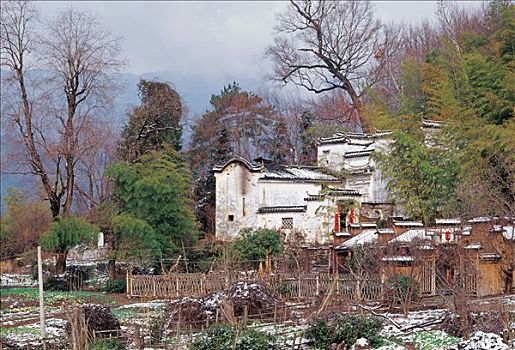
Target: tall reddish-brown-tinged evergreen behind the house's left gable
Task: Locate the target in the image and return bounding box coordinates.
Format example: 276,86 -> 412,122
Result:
189,83 -> 278,233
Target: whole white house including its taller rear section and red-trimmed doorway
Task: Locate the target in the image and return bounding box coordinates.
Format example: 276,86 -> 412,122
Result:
213,132 -> 404,243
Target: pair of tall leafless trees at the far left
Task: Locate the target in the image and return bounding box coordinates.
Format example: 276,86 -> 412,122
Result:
1,1 -> 124,217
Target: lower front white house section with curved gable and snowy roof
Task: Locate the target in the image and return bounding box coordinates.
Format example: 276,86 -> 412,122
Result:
213,158 -> 361,243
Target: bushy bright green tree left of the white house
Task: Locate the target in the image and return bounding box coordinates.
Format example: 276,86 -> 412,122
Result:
108,146 -> 196,256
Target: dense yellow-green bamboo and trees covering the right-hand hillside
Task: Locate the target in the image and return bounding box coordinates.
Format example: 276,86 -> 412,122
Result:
367,1 -> 515,222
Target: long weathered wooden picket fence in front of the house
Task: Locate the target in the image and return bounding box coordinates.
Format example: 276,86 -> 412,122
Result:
127,273 -> 383,300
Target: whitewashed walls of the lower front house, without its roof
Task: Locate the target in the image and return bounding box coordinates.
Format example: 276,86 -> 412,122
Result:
215,163 -> 334,243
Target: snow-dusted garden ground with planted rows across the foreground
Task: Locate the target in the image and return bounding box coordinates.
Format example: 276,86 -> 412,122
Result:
0,283 -> 515,350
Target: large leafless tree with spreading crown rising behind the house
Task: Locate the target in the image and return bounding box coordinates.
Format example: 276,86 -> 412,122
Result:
266,0 -> 388,130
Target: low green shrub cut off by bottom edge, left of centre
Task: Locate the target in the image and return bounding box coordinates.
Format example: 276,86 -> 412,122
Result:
189,326 -> 277,350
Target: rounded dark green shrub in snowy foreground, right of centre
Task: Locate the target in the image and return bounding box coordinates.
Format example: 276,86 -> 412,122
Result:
307,314 -> 383,349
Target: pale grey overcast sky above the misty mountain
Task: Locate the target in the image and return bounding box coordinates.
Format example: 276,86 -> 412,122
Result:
37,1 -> 480,80
